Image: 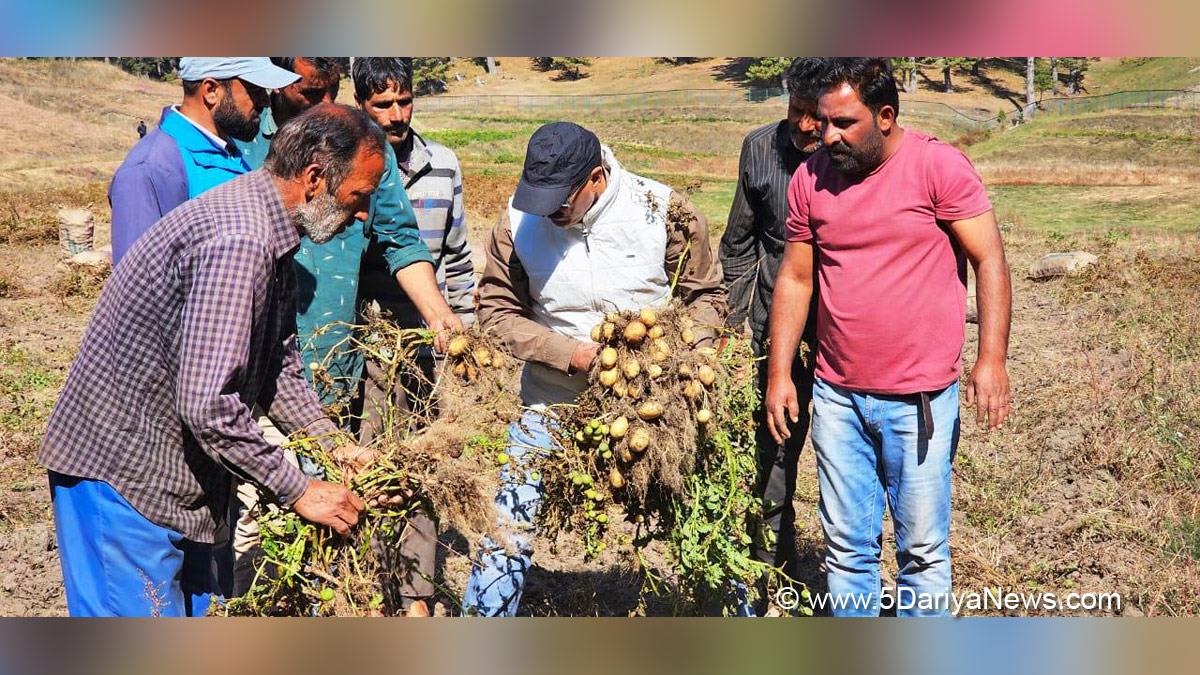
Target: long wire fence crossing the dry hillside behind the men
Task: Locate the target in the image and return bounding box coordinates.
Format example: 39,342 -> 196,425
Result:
420,88 -> 1200,131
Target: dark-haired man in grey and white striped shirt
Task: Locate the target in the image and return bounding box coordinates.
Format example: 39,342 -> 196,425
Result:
352,58 -> 475,615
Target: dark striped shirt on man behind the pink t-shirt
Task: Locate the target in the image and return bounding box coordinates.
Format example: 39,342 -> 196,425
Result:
719,120 -> 816,347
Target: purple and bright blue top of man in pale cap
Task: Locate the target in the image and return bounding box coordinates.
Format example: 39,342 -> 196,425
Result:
108,107 -> 250,265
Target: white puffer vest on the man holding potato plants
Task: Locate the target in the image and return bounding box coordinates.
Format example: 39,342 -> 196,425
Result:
509,147 -> 671,407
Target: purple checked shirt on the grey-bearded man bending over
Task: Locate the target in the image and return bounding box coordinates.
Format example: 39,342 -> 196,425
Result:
38,171 -> 334,543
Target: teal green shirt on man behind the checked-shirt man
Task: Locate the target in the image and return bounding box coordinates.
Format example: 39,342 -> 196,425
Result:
238,117 -> 433,405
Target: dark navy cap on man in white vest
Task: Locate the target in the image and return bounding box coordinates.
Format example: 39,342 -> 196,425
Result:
512,121 -> 600,216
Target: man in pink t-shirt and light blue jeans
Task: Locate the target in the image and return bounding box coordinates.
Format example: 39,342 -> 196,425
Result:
766,59 -> 1012,616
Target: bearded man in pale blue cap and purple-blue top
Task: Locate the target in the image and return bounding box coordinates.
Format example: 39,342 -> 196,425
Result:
108,56 -> 299,265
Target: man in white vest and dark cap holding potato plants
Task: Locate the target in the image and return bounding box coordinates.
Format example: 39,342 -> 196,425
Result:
463,123 -> 725,616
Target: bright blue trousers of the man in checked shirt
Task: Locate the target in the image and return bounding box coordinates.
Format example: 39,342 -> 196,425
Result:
50,471 -> 216,616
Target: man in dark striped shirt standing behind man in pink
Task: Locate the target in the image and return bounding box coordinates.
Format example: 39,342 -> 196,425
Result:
719,58 -> 823,609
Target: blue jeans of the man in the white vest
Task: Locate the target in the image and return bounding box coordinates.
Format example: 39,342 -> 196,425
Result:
462,411 -> 554,616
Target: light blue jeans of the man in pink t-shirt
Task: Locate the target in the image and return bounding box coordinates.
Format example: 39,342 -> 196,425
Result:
812,378 -> 959,616
